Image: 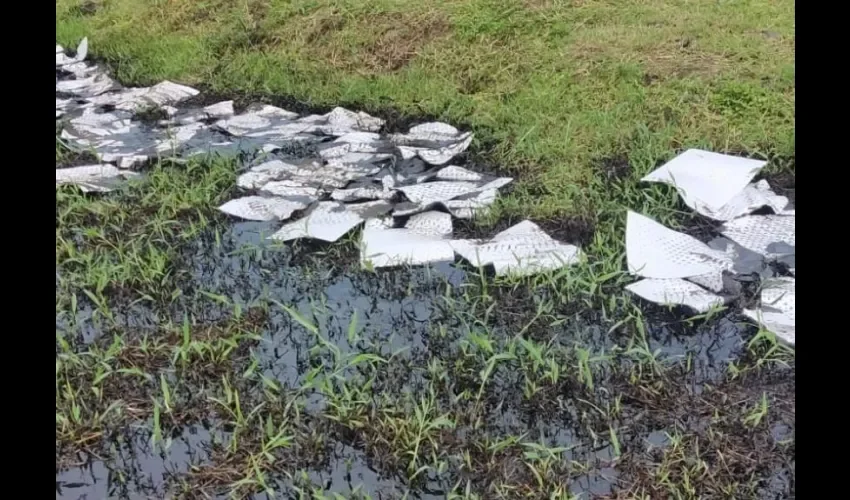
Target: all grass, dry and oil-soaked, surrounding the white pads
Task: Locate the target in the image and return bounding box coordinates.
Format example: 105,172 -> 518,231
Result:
56,0 -> 796,500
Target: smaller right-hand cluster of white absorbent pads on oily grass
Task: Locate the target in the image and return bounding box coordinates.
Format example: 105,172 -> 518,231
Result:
626,149 -> 796,344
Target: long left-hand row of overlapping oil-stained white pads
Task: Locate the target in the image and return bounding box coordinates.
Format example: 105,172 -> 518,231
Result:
56,39 -> 579,274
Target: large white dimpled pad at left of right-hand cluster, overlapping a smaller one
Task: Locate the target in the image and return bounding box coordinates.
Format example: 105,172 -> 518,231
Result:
626,211 -> 733,279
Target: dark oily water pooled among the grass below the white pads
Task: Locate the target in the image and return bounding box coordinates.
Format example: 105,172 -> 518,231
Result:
56,223 -> 789,499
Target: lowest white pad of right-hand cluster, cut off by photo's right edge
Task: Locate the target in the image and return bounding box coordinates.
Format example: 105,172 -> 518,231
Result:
744,278 -> 797,345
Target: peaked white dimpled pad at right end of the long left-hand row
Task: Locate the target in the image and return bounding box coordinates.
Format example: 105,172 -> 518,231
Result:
455,221 -> 581,276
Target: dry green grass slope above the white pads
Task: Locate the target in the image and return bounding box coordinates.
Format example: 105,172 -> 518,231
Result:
56,0 -> 795,218
